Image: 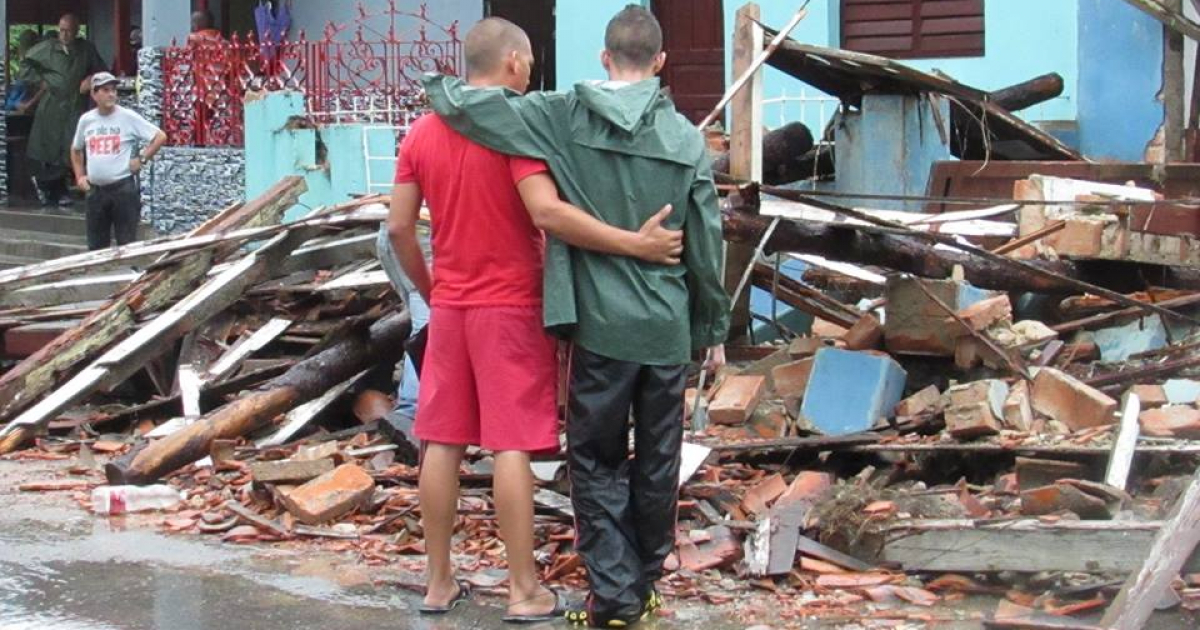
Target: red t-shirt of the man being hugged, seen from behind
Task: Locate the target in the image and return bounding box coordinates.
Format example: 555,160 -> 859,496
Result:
396,114 -> 547,307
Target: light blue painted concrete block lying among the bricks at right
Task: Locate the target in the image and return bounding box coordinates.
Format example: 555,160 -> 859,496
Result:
800,348 -> 908,436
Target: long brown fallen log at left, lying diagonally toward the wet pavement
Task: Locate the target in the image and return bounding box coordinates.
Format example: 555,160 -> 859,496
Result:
104,312 -> 410,484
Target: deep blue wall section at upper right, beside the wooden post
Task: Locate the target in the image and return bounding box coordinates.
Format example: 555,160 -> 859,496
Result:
1079,0 -> 1164,161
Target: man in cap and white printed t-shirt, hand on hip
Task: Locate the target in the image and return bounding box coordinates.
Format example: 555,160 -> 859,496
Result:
71,72 -> 167,250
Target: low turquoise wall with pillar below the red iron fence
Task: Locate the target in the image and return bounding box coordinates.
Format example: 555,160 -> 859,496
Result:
246,92 -> 396,221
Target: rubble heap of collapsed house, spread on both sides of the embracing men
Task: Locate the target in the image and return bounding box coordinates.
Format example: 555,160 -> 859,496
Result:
0,4 -> 1200,628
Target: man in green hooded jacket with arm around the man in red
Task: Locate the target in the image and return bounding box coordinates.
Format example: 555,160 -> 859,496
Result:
425,5 -> 730,628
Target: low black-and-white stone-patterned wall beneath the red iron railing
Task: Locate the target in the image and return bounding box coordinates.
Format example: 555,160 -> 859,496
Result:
142,146 -> 246,235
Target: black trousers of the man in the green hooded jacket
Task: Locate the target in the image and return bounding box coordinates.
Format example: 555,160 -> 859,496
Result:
566,347 -> 686,620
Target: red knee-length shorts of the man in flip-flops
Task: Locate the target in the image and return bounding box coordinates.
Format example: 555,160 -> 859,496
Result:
413,306 -> 558,452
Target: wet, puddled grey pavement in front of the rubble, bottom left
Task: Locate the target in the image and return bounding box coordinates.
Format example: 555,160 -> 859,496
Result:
0,461 -> 742,630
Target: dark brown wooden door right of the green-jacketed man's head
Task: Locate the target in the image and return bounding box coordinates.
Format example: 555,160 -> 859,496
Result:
652,0 -> 725,122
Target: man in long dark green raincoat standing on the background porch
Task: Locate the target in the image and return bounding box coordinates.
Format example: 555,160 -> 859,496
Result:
20,13 -> 104,204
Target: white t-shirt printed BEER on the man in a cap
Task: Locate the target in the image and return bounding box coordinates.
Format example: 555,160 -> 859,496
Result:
72,106 -> 160,186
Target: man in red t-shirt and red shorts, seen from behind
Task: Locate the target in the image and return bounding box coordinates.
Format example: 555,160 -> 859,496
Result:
388,18 -> 683,622
